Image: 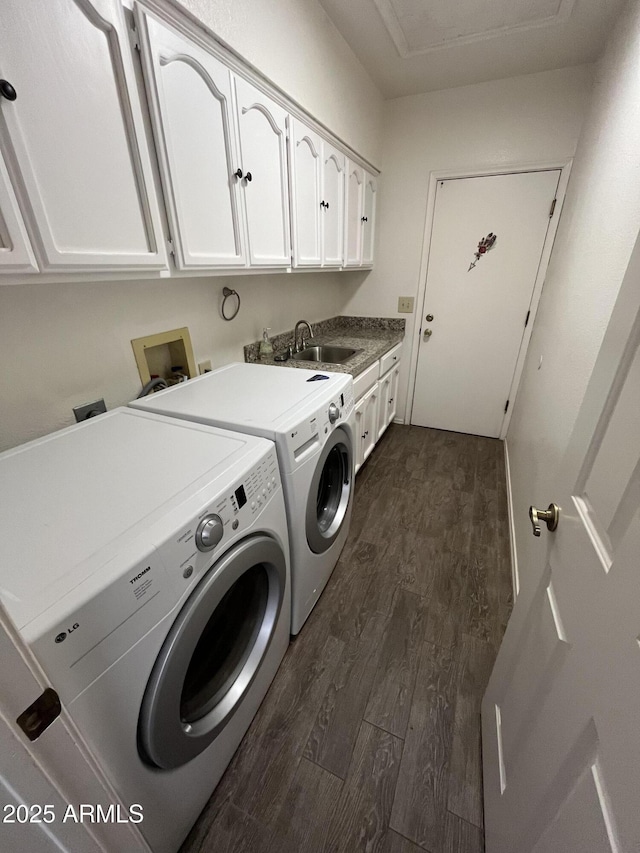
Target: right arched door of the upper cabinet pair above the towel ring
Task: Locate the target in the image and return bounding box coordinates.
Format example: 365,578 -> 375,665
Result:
235,77 -> 291,267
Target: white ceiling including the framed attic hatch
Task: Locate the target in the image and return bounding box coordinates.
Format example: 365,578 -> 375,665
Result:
319,0 -> 624,98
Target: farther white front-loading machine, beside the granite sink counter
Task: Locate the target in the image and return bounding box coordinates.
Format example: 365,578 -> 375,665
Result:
130,363 -> 355,634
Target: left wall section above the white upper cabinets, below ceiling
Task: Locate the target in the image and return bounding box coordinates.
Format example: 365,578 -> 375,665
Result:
180,0 -> 383,166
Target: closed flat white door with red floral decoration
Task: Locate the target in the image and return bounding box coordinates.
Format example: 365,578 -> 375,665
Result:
411,170 -> 560,438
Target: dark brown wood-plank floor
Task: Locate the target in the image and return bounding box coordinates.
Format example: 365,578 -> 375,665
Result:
182,425 -> 511,853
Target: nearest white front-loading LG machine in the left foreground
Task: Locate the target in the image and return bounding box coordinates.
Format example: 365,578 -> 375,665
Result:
0,409 -> 290,853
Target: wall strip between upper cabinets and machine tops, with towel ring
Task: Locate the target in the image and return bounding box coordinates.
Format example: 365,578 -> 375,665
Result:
0,273 -> 359,450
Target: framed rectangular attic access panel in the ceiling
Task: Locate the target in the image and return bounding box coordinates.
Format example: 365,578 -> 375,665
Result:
374,0 -> 575,58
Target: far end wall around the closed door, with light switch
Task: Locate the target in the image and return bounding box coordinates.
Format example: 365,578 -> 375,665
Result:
347,66 -> 592,415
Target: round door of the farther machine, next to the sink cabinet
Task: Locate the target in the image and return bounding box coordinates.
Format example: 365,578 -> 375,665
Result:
306,427 -> 353,554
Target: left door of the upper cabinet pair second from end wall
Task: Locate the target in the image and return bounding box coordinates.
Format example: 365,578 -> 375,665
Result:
290,117 -> 324,267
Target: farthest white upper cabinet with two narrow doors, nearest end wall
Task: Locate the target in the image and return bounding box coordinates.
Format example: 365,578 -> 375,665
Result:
344,160 -> 377,267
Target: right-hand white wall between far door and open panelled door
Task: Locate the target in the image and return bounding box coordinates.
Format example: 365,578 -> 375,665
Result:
507,0 -> 640,592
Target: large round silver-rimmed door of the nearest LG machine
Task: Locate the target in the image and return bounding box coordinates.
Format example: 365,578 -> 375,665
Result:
138,536 -> 287,769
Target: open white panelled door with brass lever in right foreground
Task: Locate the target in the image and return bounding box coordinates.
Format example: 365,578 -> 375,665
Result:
482,228 -> 640,853
